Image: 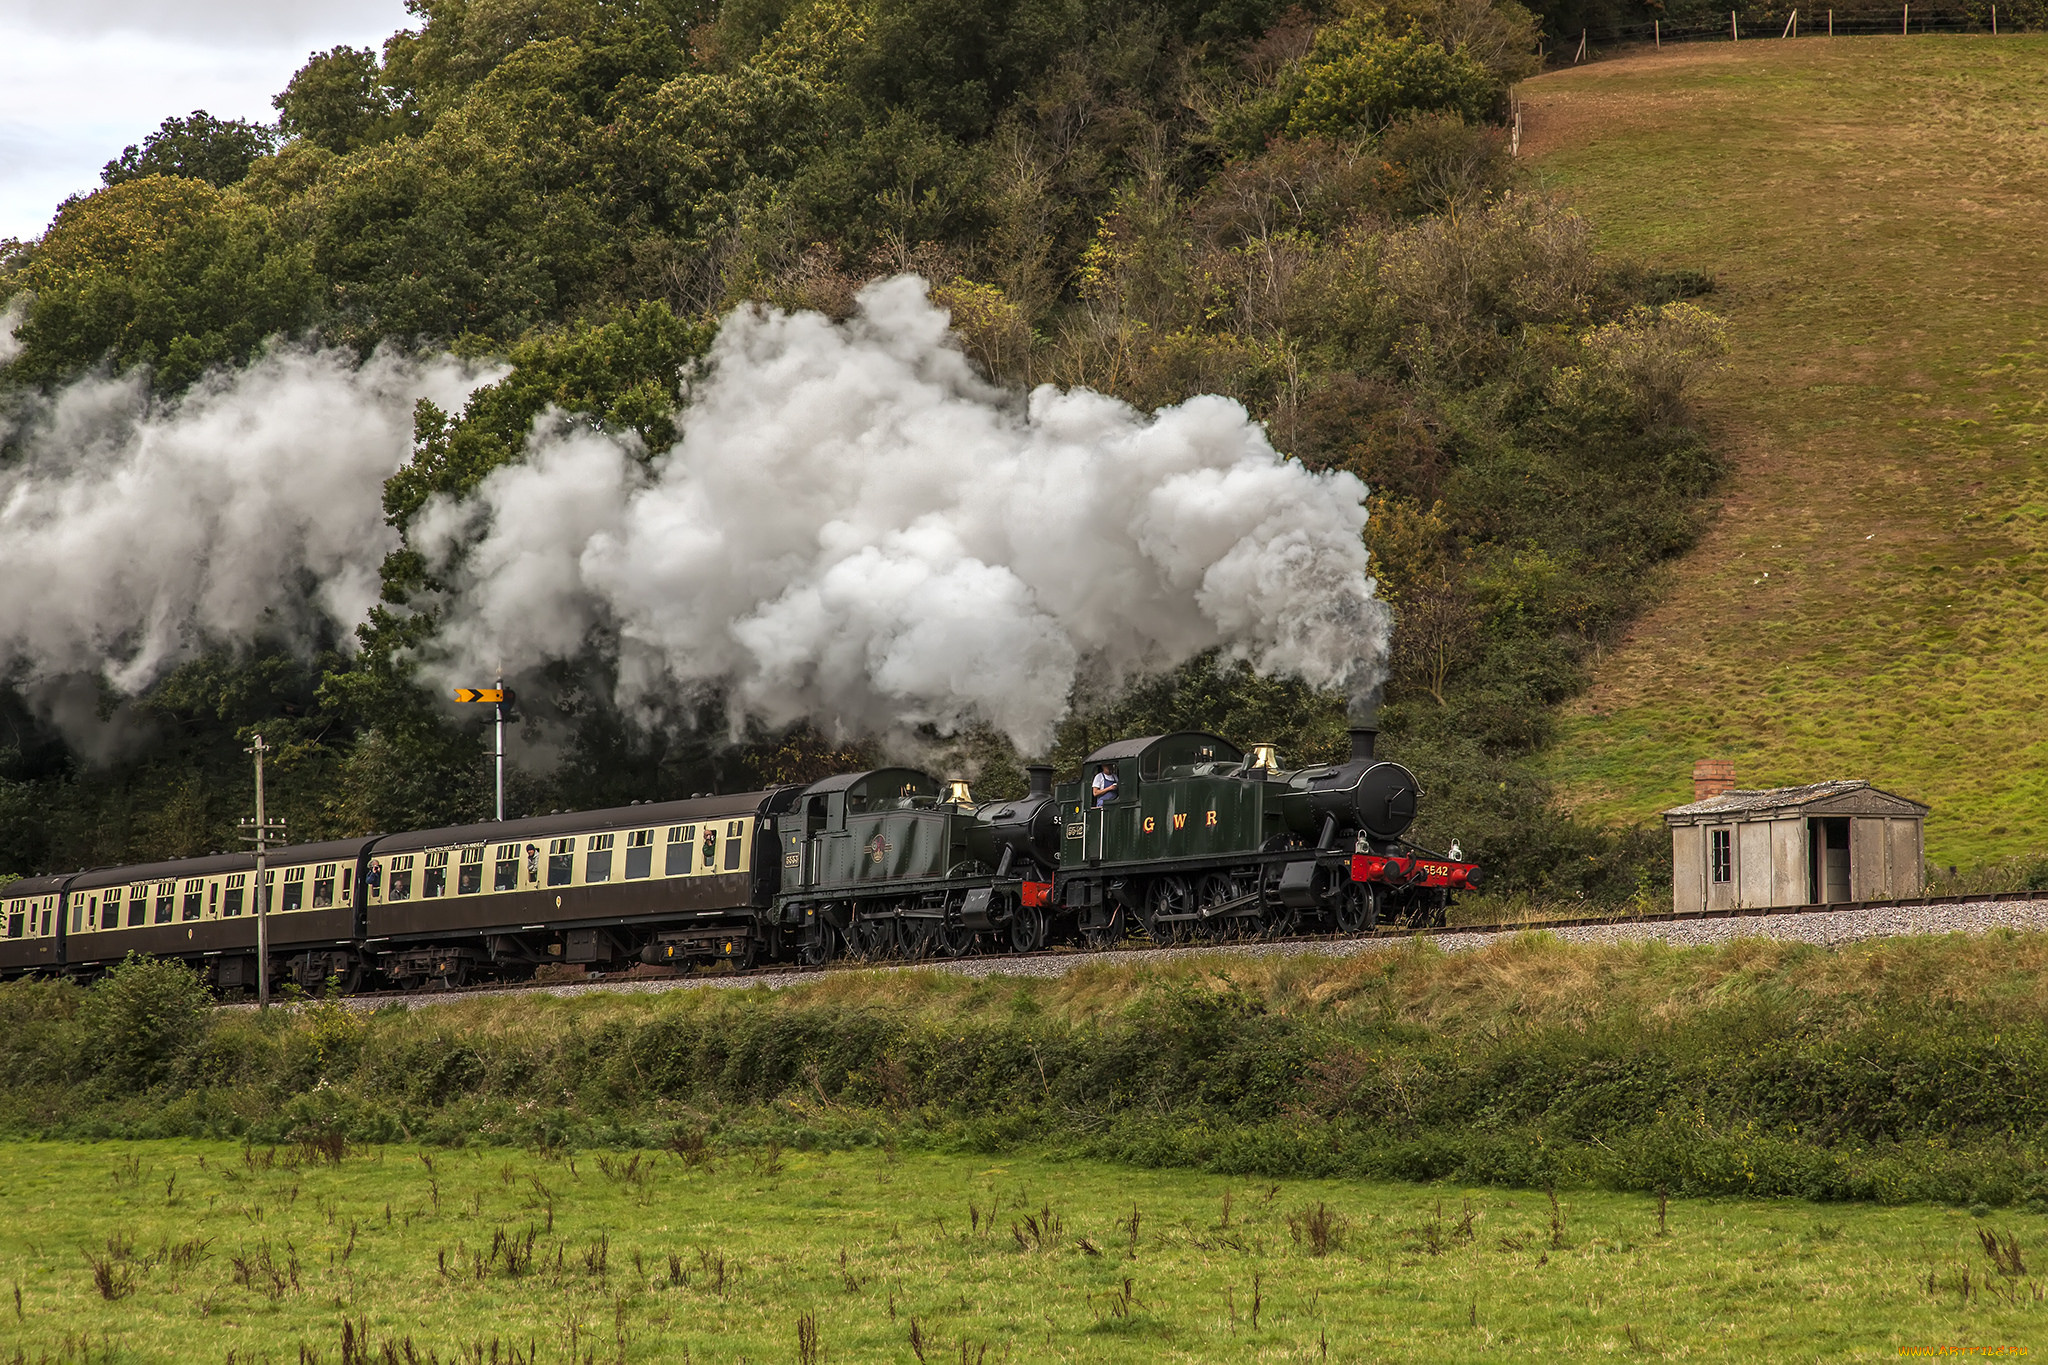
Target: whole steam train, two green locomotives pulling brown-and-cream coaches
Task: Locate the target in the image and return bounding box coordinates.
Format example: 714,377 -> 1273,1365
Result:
0,726 -> 1479,993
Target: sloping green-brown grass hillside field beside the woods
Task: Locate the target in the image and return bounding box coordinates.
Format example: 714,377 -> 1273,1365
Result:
1522,35 -> 2048,866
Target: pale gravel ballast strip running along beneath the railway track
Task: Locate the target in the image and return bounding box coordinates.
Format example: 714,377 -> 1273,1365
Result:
223,890 -> 2048,1009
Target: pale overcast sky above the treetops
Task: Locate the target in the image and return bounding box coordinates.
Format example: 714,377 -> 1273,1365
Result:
0,0 -> 408,237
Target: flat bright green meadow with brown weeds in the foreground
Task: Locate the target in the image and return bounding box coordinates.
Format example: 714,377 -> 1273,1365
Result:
0,1142 -> 2048,1363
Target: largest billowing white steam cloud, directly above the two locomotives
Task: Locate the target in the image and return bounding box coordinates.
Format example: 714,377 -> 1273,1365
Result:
414,276 -> 1389,751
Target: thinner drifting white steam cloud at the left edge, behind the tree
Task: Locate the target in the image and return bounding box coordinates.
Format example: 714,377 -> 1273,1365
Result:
0,347 -> 494,692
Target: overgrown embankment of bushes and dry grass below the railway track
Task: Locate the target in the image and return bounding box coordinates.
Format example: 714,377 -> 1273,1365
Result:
0,925 -> 2048,1212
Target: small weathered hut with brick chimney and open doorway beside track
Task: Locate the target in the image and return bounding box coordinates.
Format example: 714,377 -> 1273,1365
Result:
1663,782 -> 1927,913
